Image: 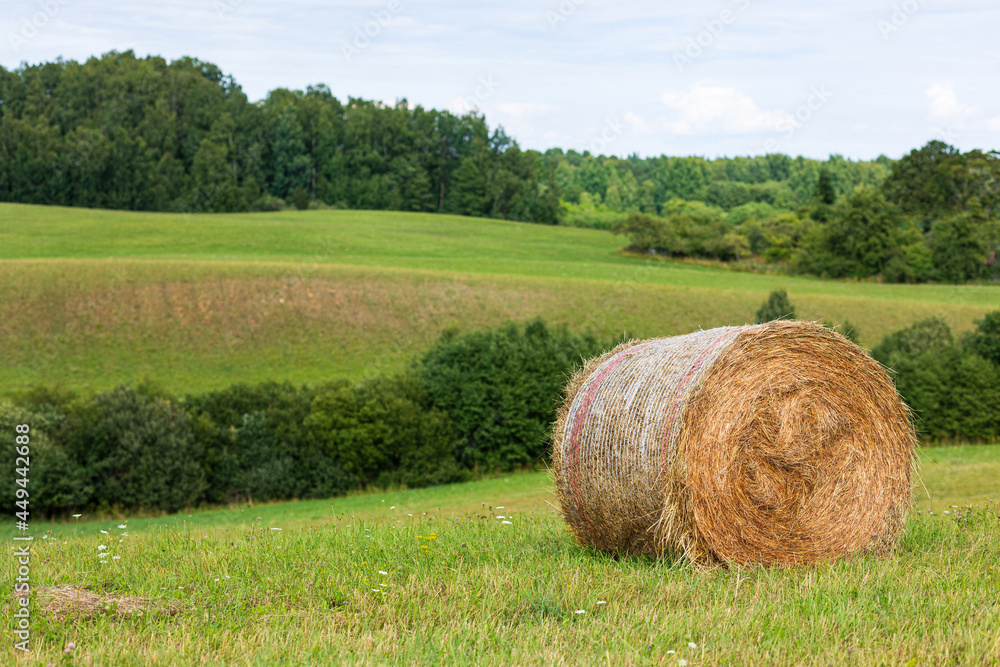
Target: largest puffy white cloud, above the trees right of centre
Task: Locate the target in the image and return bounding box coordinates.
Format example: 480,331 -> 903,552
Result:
662,84 -> 792,134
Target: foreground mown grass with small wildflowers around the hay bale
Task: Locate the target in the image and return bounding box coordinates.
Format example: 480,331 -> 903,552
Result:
3,446 -> 1000,666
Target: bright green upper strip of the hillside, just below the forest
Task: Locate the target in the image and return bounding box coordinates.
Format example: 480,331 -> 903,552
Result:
0,203 -> 1000,308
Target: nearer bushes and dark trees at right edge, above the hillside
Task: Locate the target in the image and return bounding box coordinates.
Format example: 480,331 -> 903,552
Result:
614,141 -> 1000,283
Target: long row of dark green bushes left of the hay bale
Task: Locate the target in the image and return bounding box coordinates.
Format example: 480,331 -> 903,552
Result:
0,320 -> 603,514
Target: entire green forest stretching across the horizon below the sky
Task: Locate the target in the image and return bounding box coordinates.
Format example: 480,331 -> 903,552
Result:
0,52 -> 1000,282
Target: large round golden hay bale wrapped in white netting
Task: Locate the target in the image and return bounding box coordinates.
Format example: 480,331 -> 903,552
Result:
552,321 -> 916,565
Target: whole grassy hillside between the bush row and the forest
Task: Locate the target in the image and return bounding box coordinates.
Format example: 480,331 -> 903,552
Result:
0,204 -> 1000,393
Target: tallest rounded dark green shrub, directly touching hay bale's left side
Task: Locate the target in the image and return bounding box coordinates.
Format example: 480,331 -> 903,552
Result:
419,319 -> 603,469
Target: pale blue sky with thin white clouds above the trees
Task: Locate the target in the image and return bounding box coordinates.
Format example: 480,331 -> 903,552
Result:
0,0 -> 1000,159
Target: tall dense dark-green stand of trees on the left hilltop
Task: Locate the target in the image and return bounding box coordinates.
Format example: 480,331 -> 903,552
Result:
0,51 -> 559,223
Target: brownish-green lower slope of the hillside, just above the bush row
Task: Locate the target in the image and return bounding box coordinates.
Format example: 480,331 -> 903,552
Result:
0,258 -> 1000,395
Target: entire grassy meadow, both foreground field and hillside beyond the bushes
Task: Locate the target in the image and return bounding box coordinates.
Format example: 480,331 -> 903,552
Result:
0,204 -> 1000,667
